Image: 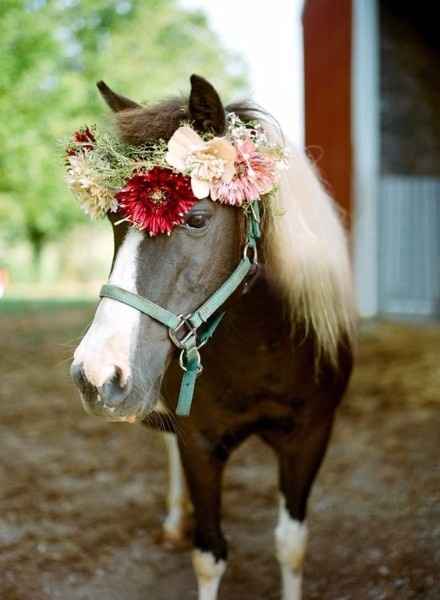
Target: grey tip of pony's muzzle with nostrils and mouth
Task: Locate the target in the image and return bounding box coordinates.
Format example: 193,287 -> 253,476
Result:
70,363 -> 140,421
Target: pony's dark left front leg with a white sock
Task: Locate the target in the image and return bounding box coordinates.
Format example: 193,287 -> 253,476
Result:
180,440 -> 227,600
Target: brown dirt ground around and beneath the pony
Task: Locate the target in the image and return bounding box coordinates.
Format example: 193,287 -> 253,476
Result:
0,309 -> 440,600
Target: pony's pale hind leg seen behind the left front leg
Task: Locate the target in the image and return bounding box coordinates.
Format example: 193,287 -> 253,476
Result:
161,433 -> 191,547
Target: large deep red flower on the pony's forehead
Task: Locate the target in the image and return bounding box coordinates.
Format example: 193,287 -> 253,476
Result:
116,167 -> 197,236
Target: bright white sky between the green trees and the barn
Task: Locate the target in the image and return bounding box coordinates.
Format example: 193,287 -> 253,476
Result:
180,0 -> 304,145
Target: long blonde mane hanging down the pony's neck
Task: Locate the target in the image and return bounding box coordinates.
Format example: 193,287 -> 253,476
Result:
264,135 -> 356,363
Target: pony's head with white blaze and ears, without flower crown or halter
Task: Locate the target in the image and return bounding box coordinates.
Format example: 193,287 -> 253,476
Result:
71,76 -> 240,420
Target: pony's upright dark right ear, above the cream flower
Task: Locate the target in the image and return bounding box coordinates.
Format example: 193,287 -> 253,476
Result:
189,75 -> 226,134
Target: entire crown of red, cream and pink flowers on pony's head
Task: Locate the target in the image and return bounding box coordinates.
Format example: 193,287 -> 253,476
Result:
65,113 -> 285,236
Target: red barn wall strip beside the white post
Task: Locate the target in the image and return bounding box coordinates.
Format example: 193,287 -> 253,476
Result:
303,0 -> 352,221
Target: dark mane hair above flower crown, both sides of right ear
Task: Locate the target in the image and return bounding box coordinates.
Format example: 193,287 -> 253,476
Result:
115,96 -> 278,146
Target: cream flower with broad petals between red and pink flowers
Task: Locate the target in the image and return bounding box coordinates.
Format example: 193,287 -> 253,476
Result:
166,125 -> 236,199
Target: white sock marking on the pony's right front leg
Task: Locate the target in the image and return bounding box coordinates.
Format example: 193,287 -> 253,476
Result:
275,496 -> 307,600
